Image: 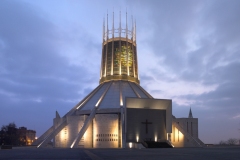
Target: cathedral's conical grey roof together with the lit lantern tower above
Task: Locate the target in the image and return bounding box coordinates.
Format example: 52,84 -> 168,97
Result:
71,14 -> 152,114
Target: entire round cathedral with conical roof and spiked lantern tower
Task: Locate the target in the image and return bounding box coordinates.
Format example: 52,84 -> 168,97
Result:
33,13 -> 204,148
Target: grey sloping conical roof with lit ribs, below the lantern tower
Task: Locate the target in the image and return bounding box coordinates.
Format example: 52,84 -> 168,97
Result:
77,80 -> 152,111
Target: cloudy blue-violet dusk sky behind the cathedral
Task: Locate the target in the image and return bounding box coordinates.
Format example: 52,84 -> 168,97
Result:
0,0 -> 240,143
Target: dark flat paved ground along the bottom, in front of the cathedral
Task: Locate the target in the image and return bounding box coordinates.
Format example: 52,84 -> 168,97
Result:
0,147 -> 240,160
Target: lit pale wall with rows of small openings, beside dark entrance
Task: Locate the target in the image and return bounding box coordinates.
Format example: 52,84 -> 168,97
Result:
93,114 -> 119,148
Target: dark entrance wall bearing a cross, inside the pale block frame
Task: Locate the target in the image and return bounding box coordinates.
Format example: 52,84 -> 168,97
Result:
126,108 -> 166,142
